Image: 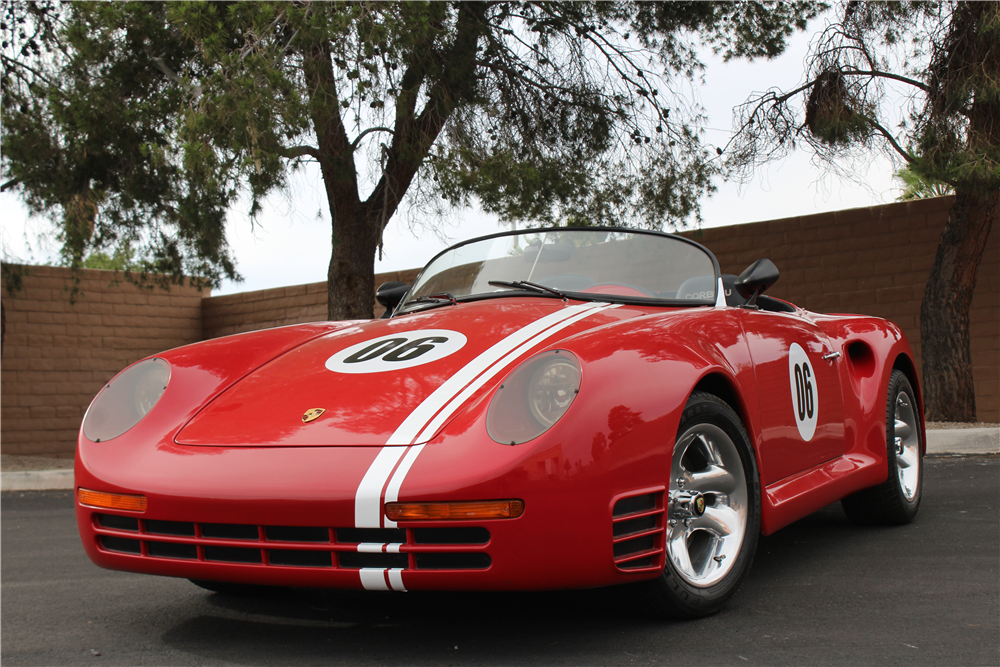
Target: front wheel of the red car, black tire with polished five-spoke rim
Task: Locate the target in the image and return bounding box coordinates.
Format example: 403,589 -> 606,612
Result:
634,392 -> 760,618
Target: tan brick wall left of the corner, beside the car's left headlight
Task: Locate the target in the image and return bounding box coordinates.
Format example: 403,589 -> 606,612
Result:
0,267 -> 202,454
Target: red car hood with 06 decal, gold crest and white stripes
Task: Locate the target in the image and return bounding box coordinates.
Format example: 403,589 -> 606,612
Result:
176,297 -> 641,447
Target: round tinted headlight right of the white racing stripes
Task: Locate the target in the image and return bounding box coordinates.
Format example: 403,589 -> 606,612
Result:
486,350 -> 582,445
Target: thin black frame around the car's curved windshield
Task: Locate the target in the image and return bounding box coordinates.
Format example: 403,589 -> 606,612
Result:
391,226 -> 726,317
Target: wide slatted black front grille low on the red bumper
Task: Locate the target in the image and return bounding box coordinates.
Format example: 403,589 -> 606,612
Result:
94,513 -> 492,570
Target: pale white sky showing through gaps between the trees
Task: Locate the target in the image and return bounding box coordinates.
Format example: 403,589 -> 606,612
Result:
0,23 -> 901,296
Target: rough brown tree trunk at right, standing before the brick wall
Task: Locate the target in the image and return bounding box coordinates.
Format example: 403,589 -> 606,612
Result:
920,189 -> 1000,422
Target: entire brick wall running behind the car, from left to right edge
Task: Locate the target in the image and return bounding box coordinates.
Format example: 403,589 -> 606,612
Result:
0,198 -> 1000,454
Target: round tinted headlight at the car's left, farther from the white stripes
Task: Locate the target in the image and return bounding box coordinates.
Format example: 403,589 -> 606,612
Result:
83,359 -> 170,442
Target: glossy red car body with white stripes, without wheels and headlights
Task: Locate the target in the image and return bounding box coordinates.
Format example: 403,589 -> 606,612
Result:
76,228 -> 923,590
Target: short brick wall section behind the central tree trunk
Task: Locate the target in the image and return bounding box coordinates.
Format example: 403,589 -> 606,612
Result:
202,269 -> 419,340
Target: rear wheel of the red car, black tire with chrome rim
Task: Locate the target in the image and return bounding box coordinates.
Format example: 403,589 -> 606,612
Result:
840,371 -> 924,526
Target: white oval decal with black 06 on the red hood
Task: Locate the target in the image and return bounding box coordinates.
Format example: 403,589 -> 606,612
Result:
326,329 -> 467,373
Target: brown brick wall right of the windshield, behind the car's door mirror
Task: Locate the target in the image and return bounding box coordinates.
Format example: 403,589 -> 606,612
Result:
685,197 -> 1000,422
